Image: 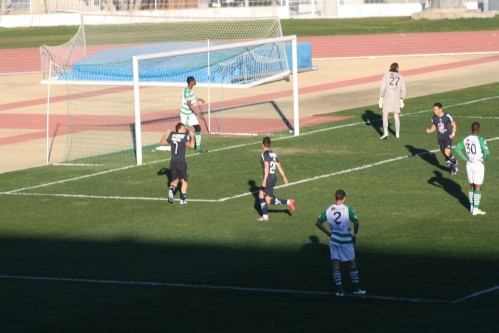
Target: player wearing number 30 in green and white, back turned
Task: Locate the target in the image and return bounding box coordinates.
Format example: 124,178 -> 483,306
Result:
455,122 -> 490,215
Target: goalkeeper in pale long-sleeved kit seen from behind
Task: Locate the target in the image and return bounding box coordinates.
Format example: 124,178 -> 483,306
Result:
378,62 -> 405,140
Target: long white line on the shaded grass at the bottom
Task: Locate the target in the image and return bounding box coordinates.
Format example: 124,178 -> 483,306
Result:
0,274 -> 451,304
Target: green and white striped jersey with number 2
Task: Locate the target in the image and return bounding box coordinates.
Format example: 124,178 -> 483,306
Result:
319,204 -> 358,246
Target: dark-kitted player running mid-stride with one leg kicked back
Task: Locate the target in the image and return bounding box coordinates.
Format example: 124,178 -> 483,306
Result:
258,136 -> 295,221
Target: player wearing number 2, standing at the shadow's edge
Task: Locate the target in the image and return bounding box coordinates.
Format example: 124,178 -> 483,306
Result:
315,190 -> 366,296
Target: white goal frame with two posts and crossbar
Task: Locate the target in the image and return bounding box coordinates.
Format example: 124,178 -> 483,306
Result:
132,36 -> 300,165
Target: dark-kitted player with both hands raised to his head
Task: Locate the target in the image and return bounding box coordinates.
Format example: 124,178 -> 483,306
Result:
160,123 -> 195,205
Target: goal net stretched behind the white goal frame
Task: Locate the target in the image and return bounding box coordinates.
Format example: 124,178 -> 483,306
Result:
41,15 -> 299,164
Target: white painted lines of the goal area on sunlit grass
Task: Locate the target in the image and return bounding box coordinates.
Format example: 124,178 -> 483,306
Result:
0,96 -> 499,198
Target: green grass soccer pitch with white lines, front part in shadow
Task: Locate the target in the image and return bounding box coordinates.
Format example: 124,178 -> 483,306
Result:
0,84 -> 499,332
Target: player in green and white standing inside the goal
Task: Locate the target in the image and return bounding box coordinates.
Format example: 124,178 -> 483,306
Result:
180,76 -> 206,153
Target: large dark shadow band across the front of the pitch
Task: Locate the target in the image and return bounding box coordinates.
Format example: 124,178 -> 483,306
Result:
0,235 -> 499,332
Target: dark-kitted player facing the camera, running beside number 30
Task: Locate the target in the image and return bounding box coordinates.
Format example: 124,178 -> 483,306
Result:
426,103 -> 458,176
